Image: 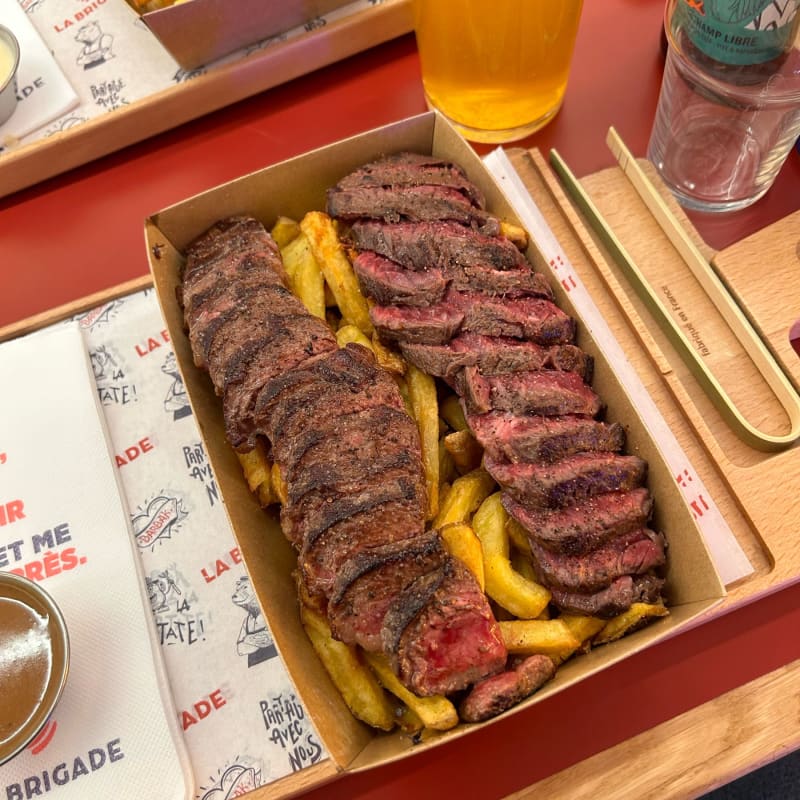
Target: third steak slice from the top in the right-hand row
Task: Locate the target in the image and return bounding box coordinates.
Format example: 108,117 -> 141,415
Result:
350,221 -> 530,270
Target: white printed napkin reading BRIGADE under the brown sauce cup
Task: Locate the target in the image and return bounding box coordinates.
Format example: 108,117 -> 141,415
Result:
0,323 -> 194,800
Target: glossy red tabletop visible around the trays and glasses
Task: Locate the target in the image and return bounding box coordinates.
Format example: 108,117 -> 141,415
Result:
0,0 -> 800,800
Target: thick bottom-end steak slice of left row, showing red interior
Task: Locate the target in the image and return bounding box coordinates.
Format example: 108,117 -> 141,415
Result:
382,557 -> 507,697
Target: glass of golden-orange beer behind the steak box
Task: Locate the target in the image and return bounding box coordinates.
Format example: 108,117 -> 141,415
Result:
413,0 -> 583,143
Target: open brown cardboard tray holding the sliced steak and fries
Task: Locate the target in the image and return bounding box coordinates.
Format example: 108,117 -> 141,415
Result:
145,113 -> 725,788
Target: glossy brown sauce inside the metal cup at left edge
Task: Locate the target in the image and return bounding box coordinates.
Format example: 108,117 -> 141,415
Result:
0,597 -> 53,744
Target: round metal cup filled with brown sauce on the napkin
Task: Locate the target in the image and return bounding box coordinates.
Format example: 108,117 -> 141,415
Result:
0,572 -> 69,764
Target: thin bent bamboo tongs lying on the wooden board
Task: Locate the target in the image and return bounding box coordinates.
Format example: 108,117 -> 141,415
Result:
550,128 -> 800,452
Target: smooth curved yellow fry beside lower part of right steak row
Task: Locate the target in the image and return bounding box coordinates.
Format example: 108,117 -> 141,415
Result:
472,492 -> 551,620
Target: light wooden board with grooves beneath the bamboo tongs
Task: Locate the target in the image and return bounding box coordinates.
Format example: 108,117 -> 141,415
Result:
508,149 -> 800,614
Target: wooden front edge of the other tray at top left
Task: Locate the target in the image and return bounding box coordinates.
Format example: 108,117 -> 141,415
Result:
0,0 -> 412,202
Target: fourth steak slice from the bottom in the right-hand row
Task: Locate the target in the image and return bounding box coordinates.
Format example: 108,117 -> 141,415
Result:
483,453 -> 647,508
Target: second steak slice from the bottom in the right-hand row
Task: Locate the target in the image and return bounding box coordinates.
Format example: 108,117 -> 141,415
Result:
530,528 -> 666,592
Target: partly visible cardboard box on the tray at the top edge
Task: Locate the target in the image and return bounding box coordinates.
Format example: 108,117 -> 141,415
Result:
142,0 -> 351,69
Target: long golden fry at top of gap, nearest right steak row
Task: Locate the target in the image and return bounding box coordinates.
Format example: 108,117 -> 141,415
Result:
300,211 -> 374,336
